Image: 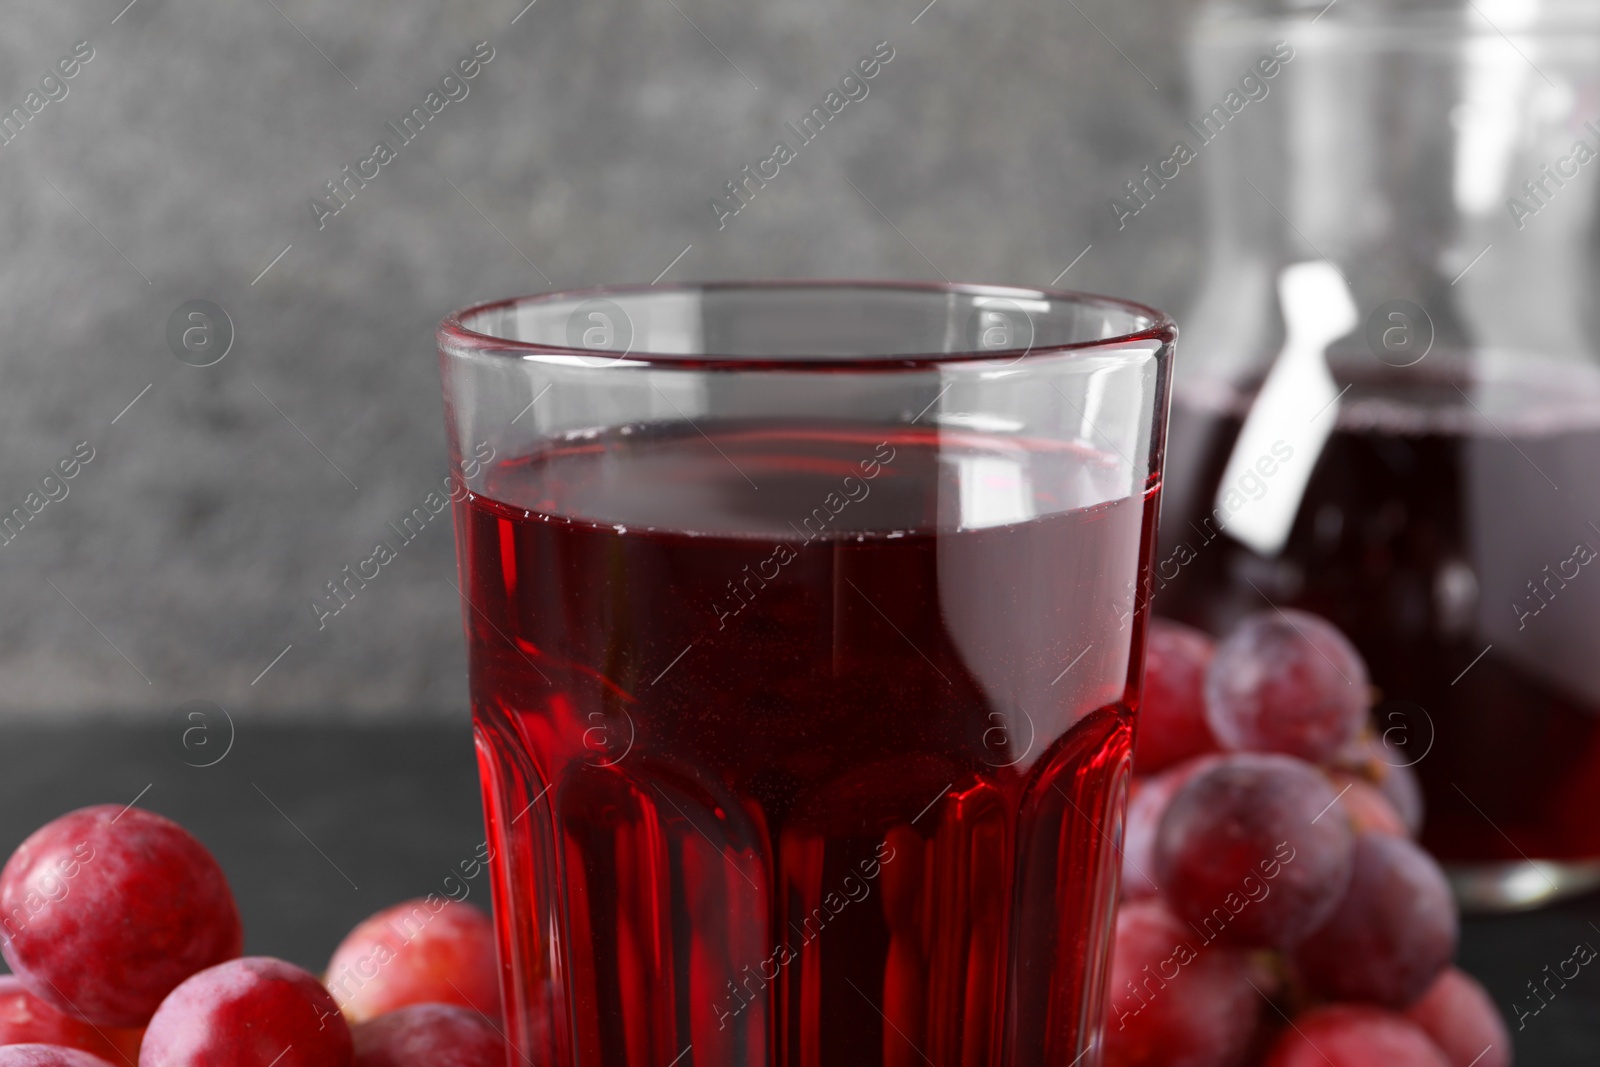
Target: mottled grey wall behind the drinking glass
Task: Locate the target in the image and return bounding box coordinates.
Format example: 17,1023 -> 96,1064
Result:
0,0 -> 1203,715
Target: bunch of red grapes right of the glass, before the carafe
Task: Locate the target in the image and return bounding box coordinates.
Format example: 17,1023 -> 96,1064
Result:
1102,611 -> 1512,1067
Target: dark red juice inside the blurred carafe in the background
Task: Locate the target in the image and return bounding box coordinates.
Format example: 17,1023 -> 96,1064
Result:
1155,354 -> 1600,864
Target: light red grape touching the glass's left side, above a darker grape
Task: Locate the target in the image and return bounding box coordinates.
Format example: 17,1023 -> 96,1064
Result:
328,896 -> 499,1022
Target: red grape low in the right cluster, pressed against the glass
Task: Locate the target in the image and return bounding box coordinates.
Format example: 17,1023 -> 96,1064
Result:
1104,901 -> 1262,1067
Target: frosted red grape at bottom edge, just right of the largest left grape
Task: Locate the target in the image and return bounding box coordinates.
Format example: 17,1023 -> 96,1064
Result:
139,957 -> 352,1067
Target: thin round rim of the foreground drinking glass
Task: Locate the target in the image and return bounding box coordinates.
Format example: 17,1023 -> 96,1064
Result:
435,278 -> 1178,373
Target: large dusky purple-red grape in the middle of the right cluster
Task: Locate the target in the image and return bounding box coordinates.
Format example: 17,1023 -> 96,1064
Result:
1155,753 -> 1355,949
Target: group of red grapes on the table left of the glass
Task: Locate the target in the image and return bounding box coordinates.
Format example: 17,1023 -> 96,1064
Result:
0,805 -> 506,1067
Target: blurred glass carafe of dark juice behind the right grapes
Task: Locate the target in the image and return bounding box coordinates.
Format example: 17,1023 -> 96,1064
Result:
1158,0 -> 1600,909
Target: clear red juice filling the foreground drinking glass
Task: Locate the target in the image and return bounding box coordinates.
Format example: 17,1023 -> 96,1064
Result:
458,426 -> 1157,1067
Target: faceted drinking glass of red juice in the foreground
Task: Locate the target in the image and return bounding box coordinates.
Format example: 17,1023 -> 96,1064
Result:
438,282 -> 1176,1067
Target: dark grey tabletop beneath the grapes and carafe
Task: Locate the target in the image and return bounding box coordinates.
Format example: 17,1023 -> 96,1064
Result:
0,713 -> 1600,1067
